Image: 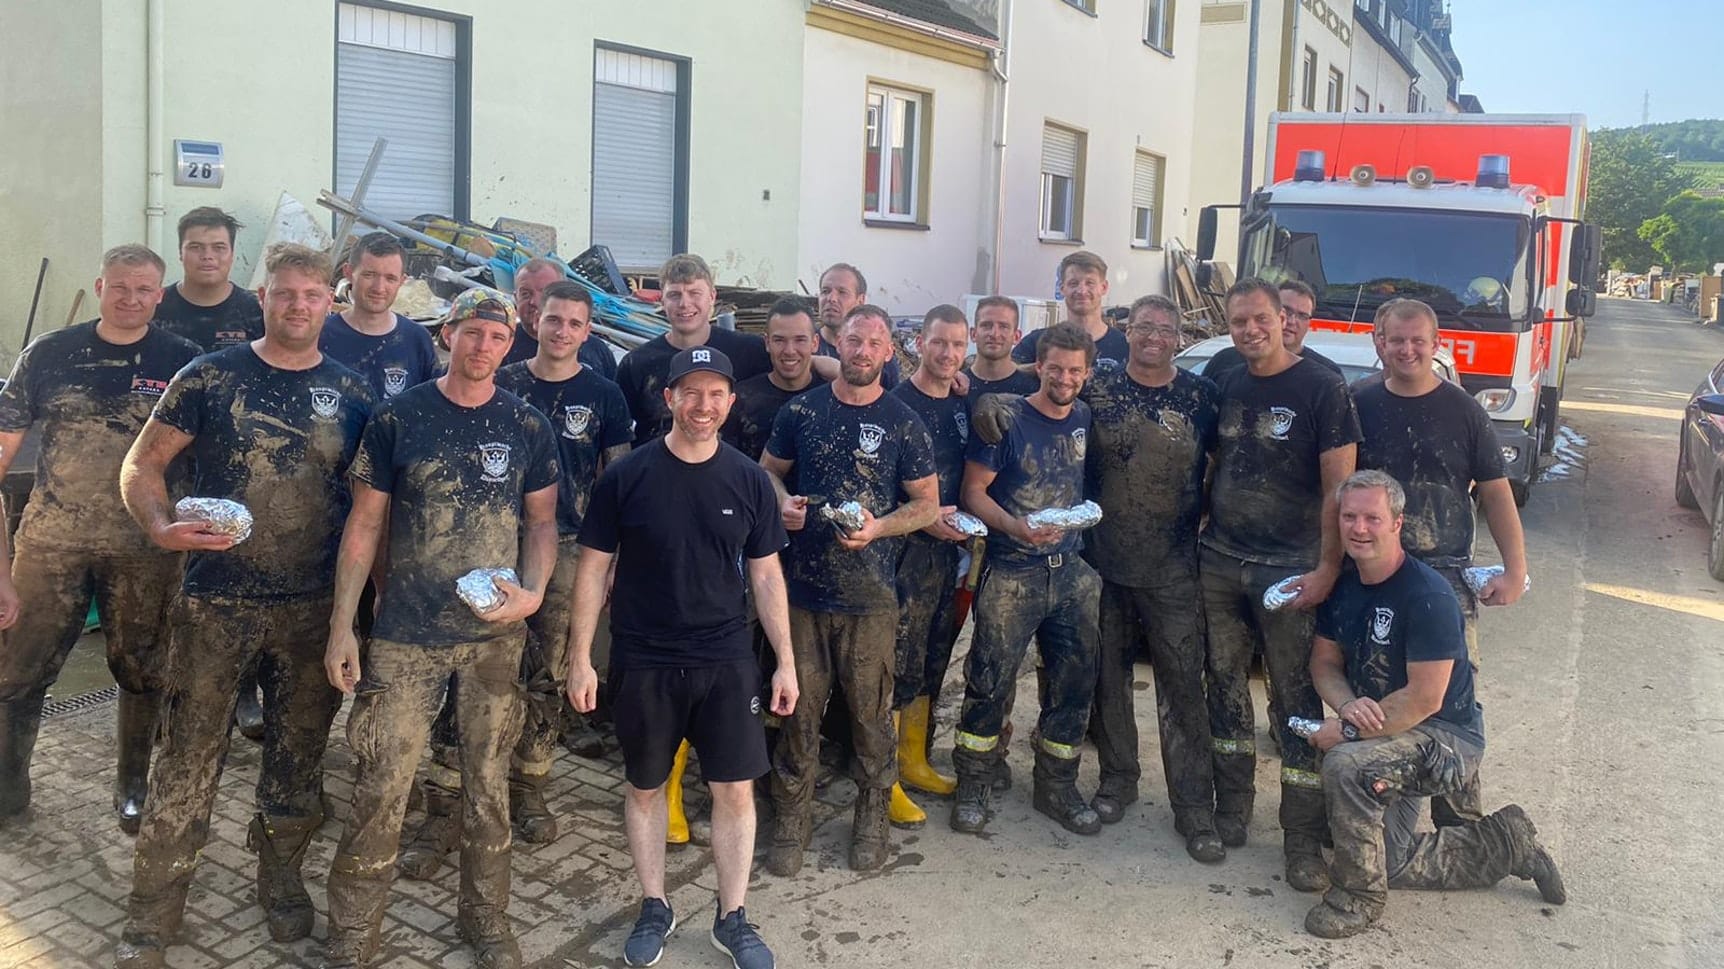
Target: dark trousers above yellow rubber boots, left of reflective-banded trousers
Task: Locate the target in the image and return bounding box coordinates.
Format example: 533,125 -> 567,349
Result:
891,533 -> 964,710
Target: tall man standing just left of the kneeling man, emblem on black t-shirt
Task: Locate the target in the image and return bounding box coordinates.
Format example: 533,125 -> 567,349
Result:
1198,279 -> 1359,891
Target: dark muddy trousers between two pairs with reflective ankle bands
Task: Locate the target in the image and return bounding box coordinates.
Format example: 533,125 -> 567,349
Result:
1090,569 -> 1215,836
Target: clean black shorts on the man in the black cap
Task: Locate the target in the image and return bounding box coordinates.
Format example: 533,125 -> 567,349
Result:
610,659 -> 771,791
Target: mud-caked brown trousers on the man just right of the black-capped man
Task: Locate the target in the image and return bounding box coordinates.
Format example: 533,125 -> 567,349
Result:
772,605 -> 898,819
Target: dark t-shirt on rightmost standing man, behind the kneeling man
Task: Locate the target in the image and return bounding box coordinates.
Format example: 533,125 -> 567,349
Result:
1353,381 -> 1505,567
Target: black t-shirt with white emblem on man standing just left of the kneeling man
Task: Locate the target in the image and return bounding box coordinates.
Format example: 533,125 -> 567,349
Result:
1203,359 -> 1359,569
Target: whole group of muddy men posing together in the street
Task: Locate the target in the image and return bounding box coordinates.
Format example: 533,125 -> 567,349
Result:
0,209 -> 1564,969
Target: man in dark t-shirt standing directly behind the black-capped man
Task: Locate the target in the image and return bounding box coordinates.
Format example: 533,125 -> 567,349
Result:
617,252 -> 772,447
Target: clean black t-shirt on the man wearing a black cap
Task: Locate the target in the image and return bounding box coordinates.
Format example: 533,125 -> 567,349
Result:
581,440 -> 784,669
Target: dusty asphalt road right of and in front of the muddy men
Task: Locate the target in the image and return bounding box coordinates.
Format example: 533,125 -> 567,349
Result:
706,300 -> 1724,969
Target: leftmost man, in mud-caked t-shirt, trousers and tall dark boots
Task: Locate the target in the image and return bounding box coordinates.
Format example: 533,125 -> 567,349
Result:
0,245 -> 200,835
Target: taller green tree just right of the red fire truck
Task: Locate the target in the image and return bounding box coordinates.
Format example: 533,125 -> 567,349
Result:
1586,131 -> 1688,272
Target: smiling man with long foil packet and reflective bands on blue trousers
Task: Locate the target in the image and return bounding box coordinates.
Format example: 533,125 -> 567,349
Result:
952,322 -> 1102,835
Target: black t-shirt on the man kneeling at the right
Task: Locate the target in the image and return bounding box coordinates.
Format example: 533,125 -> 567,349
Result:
1317,555 -> 1484,745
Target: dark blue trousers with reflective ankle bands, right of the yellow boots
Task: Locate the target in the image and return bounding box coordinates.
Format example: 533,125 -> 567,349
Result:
952,555 -> 1102,778
